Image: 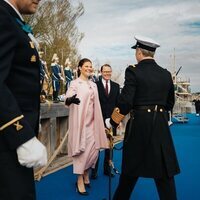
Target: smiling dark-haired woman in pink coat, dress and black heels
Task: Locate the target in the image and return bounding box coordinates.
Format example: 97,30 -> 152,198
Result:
65,58 -> 108,195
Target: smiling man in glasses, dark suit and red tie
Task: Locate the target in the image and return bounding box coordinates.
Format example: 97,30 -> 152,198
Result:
91,64 -> 119,179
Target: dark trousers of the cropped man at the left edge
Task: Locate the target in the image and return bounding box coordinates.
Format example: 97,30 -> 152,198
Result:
0,150 -> 36,200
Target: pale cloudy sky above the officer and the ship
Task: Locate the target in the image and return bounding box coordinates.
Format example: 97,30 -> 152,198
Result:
76,0 -> 200,92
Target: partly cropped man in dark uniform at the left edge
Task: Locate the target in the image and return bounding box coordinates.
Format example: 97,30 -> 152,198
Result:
0,0 -> 47,200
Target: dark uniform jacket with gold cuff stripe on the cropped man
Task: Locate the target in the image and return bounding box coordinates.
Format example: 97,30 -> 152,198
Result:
0,1 -> 40,152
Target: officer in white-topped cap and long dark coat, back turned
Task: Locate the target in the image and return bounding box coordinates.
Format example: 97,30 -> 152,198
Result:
106,36 -> 180,200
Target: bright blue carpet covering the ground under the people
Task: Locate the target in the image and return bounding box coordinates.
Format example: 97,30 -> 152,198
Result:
36,114 -> 200,200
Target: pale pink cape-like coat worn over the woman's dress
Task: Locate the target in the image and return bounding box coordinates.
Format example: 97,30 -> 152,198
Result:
66,78 -> 108,156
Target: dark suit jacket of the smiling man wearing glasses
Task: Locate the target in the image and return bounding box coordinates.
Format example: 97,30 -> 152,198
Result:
96,79 -> 119,123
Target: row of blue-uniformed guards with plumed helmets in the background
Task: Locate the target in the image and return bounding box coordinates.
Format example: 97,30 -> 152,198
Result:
39,49 -> 99,103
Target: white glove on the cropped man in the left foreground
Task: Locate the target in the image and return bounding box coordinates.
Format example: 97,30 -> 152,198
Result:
17,137 -> 47,168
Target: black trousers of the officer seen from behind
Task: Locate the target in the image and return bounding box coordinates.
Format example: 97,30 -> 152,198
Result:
113,174 -> 177,200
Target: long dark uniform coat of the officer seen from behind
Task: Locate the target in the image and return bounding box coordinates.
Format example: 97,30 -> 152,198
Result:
111,59 -> 179,178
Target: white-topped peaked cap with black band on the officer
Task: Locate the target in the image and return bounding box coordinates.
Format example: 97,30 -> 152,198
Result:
131,36 -> 160,52
